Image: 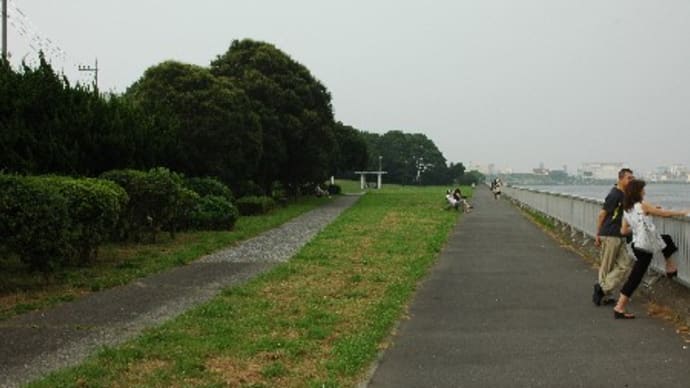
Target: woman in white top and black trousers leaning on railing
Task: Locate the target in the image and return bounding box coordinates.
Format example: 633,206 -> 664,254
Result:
613,179 -> 688,319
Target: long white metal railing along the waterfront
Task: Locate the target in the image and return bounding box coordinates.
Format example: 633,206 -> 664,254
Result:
501,186 -> 690,287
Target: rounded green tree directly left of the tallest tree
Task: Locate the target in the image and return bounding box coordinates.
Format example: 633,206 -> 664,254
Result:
126,61 -> 262,187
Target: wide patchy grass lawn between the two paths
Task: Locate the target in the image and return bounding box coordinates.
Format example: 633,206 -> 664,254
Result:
30,187 -> 468,387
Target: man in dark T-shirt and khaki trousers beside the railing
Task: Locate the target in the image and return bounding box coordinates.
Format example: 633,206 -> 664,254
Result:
592,168 -> 634,306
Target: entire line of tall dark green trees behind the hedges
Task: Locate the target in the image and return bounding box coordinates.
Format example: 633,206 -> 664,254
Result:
0,40 -> 472,191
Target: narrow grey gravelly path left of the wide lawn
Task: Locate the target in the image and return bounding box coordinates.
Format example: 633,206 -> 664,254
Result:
0,196 -> 359,387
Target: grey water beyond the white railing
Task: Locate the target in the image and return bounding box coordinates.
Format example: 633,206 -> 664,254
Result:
529,183 -> 690,210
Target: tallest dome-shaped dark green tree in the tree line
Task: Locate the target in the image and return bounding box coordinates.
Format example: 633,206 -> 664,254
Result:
211,39 -> 336,191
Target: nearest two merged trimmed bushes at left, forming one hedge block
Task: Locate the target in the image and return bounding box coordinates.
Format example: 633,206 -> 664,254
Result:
0,175 -> 127,272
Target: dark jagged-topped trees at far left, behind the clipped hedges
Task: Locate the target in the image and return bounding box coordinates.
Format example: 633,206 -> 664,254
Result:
0,56 -> 153,175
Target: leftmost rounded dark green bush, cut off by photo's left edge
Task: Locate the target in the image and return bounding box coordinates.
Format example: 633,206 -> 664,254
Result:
0,175 -> 72,272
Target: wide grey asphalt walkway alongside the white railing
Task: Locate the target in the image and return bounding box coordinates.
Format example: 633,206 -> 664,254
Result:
369,188 -> 690,388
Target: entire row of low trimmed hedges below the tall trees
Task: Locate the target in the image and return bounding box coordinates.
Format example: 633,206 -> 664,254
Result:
0,168 -> 242,272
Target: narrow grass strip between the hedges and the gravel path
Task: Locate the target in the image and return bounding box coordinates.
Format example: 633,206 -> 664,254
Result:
0,197 -> 327,320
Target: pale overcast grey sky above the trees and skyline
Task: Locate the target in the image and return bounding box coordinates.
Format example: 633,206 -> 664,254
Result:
8,0 -> 690,173
